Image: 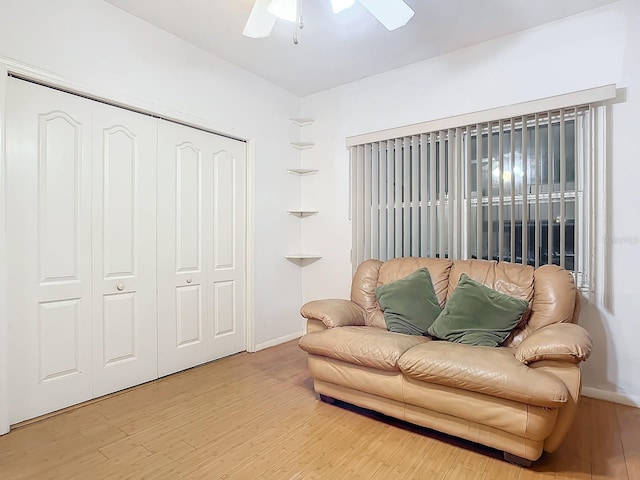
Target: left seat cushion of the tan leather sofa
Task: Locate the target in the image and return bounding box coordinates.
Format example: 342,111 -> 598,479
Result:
299,327 -> 430,371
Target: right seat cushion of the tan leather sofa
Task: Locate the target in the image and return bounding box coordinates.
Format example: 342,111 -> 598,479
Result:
398,341 -> 569,407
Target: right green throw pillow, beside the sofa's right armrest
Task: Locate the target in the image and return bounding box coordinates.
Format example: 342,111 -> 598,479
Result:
427,273 -> 529,347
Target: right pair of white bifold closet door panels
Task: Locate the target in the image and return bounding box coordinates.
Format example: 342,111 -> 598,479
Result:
158,121 -> 246,376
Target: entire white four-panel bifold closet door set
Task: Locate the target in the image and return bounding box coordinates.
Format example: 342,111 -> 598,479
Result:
6,78 -> 246,423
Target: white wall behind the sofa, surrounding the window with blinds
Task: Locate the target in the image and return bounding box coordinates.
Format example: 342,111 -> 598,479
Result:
302,0 -> 640,405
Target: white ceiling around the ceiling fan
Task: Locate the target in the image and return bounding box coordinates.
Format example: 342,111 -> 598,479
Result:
105,0 -> 616,97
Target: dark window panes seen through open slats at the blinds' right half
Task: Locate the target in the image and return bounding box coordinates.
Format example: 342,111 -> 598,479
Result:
463,108 -> 588,270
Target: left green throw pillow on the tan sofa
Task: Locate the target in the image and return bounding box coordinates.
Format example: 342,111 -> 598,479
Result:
376,268 -> 441,335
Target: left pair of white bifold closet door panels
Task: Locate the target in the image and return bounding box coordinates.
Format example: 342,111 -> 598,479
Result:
6,78 -> 157,423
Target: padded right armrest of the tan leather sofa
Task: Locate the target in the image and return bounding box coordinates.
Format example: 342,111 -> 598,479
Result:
516,323 -> 593,365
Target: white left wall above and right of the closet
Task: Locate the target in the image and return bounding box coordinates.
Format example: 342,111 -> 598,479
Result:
0,0 -> 303,346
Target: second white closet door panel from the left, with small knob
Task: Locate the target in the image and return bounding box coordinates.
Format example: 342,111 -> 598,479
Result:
92,102 -> 158,397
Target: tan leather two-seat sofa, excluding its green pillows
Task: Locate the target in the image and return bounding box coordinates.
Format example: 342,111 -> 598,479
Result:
299,258 -> 592,465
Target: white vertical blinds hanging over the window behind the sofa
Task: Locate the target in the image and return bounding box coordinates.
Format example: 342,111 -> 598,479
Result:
350,105 -> 591,286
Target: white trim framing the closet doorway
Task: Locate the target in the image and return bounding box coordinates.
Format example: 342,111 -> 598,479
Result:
0,57 -> 256,435
